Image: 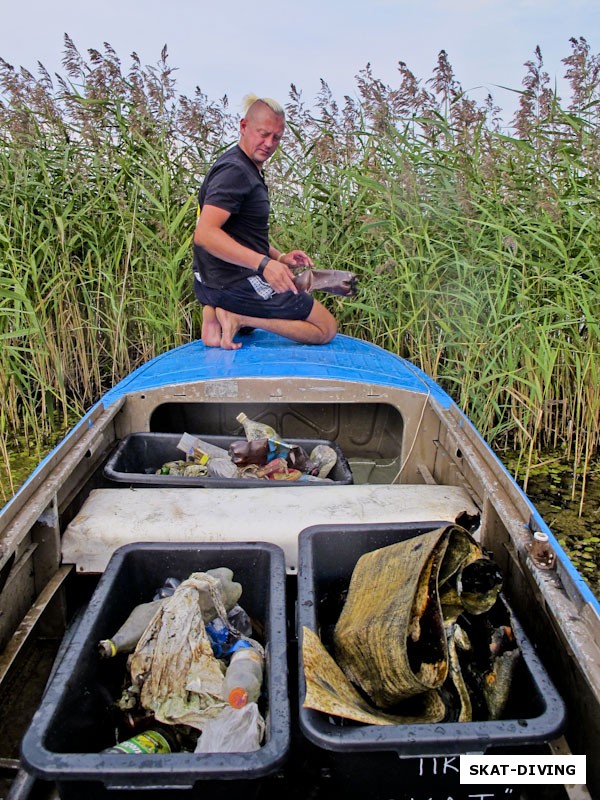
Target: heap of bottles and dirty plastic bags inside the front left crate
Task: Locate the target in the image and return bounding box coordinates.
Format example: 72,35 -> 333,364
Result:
98,567 -> 265,753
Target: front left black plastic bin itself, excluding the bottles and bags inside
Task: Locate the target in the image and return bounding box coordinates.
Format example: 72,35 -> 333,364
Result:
22,543 -> 290,800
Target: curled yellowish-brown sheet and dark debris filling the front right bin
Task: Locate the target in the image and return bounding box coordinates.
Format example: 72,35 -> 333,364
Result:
302,525 -> 520,725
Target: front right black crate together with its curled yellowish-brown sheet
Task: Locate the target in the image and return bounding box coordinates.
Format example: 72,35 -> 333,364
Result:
297,522 -> 565,800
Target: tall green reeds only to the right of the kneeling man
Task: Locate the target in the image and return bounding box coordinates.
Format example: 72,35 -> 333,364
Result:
270,59 -> 600,488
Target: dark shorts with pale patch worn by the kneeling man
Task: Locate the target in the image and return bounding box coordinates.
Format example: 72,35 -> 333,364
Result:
194,275 -> 315,320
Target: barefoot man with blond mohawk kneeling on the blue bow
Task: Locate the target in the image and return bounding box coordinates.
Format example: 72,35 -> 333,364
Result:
194,95 -> 337,350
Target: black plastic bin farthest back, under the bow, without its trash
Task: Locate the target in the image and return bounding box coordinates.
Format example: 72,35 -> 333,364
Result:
104,433 -> 352,488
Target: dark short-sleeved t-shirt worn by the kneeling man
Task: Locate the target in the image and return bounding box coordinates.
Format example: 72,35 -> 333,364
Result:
194,145 -> 269,289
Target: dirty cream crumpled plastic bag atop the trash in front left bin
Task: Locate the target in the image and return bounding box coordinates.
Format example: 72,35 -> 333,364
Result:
129,570 -> 262,729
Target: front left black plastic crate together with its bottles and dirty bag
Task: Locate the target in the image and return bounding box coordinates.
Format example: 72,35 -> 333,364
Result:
22,542 -> 290,800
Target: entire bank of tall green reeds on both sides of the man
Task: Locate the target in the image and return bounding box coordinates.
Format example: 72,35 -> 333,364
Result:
0,37 -> 600,500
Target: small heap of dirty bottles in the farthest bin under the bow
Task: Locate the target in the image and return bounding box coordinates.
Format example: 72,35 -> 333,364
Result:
156,412 -> 337,482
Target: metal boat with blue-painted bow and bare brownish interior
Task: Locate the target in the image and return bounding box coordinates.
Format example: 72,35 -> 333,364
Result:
0,331 -> 600,798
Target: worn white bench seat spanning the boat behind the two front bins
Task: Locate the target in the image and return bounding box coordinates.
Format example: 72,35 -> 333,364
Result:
62,484 -> 480,573
